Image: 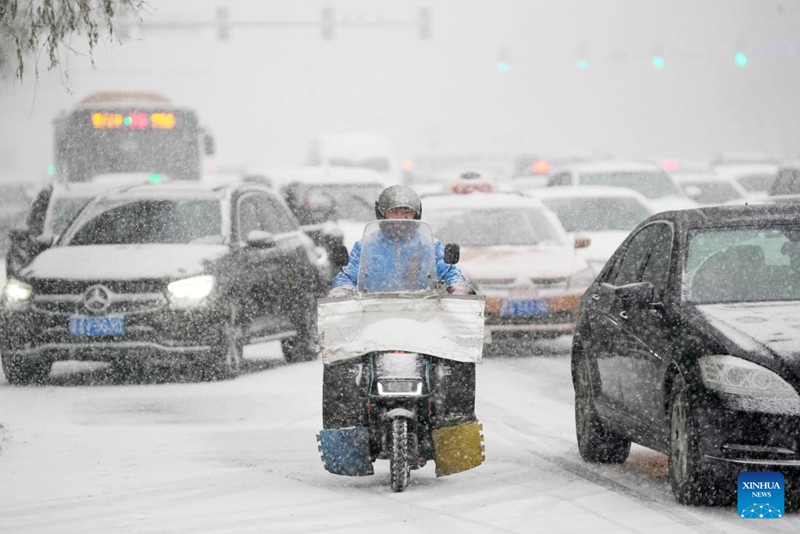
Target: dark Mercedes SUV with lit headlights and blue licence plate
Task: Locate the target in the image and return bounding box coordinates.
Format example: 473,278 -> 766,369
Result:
0,182 -> 327,384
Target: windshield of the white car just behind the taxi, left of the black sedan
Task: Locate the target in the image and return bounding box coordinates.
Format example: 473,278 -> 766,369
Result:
542,197 -> 650,232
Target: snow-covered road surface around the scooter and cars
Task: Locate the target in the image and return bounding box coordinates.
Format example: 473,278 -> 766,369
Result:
0,338 -> 800,534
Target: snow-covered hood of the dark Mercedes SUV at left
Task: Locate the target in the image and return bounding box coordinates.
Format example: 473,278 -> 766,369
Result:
21,244 -> 229,280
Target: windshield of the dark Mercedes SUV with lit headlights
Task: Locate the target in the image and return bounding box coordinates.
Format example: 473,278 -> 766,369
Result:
65,199 -> 222,246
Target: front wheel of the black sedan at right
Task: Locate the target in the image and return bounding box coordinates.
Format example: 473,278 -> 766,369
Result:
669,376 -> 723,506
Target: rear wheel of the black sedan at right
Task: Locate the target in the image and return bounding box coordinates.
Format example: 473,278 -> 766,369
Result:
575,359 -> 631,464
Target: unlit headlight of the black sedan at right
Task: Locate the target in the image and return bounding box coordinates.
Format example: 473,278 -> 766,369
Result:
699,355 -> 800,414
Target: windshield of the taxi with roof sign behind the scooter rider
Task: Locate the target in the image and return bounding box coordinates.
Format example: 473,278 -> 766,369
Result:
426,207 -> 565,247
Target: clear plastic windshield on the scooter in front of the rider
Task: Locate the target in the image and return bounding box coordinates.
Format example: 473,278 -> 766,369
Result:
358,219 -> 437,293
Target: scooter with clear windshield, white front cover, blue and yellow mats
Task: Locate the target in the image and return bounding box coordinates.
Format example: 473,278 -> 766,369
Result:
317,220 -> 484,492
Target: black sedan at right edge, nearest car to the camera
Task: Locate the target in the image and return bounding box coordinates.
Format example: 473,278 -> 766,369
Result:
572,204 -> 800,504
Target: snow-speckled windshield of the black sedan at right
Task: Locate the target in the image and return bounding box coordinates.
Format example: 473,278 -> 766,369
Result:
683,226 -> 800,304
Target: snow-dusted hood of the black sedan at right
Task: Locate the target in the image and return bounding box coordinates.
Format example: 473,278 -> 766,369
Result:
697,301 -> 800,360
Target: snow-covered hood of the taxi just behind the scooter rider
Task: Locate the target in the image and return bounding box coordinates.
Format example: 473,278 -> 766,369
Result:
458,246 -> 588,279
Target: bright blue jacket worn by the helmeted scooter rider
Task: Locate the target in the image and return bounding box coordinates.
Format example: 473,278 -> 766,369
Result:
333,233 -> 466,291
